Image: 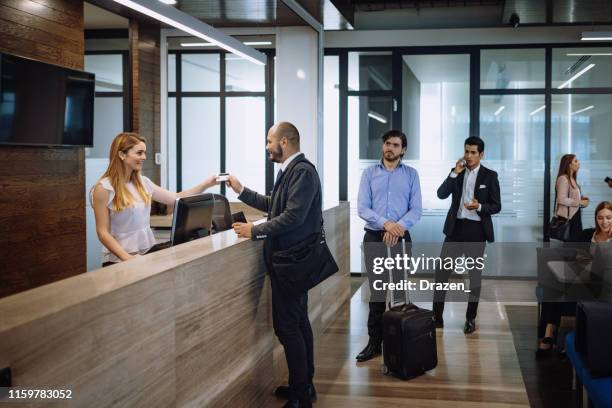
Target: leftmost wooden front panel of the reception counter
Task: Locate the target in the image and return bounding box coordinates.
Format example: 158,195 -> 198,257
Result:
0,271 -> 176,407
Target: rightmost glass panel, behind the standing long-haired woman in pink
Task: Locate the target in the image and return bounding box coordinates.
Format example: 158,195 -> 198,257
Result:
550,47 -> 612,228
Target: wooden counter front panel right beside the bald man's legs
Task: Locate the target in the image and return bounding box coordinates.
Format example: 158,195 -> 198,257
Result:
175,242 -> 274,407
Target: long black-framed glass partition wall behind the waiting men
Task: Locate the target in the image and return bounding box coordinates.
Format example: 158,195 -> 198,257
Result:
324,43 -> 612,272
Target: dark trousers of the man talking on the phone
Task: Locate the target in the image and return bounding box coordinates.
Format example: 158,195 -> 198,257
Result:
433,219 -> 486,320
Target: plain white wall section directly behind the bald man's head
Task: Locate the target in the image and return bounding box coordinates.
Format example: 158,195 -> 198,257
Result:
275,27 -> 322,166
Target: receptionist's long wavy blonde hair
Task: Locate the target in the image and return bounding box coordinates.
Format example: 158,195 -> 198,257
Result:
100,132 -> 151,212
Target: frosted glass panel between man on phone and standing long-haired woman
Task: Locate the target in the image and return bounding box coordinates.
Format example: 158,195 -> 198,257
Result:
479,48 -> 546,242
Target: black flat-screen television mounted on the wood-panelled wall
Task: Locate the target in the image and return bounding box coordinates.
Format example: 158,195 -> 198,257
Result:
0,53 -> 95,147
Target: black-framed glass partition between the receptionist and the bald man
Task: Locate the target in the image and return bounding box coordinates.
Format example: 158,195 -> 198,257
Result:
168,50 -> 273,201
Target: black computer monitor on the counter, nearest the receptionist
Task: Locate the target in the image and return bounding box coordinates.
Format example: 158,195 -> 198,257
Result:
171,193 -> 215,246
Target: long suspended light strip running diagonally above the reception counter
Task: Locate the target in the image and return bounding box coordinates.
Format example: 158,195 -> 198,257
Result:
114,0 -> 266,65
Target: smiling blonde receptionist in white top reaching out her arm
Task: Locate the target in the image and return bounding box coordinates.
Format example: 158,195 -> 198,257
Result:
90,133 -> 217,266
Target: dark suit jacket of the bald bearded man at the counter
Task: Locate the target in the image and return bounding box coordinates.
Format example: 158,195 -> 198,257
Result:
238,153 -> 323,252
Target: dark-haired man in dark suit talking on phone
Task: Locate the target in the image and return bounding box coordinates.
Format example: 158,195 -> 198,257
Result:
433,136 -> 501,334
